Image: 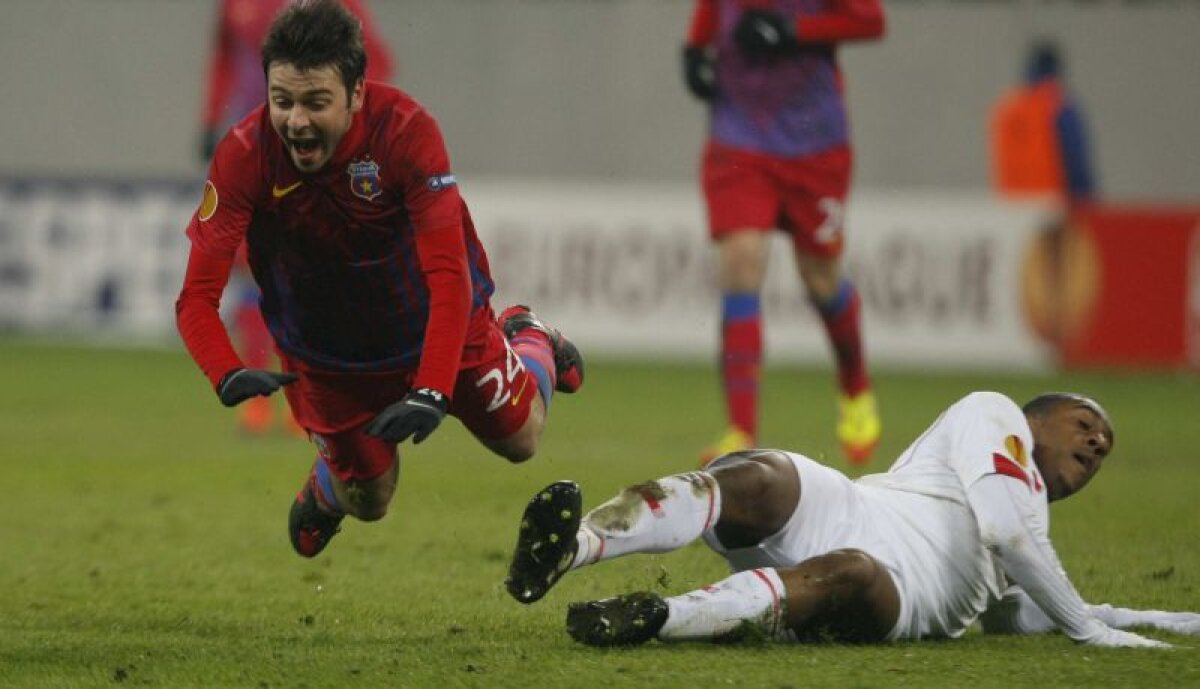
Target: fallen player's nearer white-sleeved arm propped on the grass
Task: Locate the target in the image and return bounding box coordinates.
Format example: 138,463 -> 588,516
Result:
967,474 -> 1170,648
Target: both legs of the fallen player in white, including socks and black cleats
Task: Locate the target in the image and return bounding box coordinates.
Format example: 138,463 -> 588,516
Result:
505,451 -> 899,646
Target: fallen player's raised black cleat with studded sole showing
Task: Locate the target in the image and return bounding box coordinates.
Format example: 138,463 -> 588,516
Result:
504,481 -> 583,605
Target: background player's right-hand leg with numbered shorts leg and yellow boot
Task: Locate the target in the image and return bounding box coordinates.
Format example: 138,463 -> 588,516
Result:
785,148 -> 881,465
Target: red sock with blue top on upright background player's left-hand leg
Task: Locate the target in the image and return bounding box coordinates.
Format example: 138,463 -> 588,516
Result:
721,294 -> 762,438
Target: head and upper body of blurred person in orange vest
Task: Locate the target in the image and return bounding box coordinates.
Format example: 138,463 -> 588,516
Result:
991,40 -> 1097,209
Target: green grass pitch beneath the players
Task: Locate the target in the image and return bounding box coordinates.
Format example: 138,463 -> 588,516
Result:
0,338 -> 1200,689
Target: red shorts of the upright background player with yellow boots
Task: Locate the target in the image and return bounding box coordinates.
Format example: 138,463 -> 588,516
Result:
701,140 -> 853,258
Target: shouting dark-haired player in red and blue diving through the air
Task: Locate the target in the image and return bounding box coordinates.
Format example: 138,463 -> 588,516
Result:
176,0 -> 583,557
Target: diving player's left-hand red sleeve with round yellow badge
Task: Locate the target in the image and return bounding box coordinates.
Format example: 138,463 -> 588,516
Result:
175,126 -> 260,388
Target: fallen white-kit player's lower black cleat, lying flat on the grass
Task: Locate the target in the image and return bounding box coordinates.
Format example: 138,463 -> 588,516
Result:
566,592 -> 670,646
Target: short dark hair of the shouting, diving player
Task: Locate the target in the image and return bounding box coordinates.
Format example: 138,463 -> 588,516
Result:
263,0 -> 367,101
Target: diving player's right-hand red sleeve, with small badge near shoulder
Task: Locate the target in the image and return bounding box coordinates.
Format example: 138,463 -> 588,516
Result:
392,110 -> 472,396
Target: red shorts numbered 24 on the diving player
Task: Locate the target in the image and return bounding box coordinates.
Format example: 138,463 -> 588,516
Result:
281,318 -> 538,481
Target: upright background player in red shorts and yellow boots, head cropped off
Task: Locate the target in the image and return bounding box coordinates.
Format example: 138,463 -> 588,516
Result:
684,0 -> 884,463
